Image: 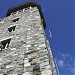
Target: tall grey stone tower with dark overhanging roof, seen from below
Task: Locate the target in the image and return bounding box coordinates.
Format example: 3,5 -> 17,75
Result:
0,1 -> 56,75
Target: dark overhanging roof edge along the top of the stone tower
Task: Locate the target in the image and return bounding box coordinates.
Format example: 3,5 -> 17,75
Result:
6,0 -> 46,29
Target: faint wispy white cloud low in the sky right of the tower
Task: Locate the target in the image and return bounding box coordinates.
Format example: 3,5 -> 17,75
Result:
56,53 -> 75,73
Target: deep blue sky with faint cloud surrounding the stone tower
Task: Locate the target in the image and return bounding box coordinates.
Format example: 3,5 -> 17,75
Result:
0,0 -> 74,75
